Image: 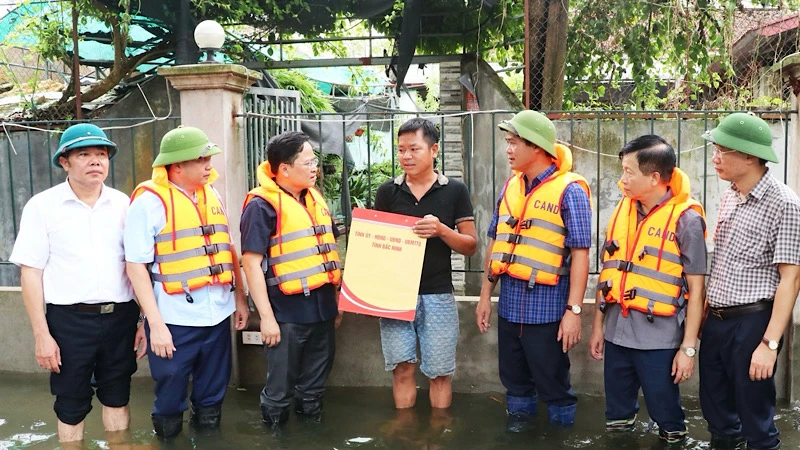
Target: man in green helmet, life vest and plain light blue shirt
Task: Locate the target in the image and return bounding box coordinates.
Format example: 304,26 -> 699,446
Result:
125,127 -> 249,439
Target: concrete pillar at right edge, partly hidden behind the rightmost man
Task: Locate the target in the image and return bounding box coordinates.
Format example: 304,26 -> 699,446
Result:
770,53 -> 800,402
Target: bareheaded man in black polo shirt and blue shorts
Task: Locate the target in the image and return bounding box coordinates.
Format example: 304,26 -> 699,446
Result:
375,118 -> 477,409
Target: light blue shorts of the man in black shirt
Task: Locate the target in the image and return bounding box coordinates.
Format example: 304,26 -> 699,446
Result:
380,293 -> 458,378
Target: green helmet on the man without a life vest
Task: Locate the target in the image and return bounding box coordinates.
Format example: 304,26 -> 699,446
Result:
703,113 -> 778,163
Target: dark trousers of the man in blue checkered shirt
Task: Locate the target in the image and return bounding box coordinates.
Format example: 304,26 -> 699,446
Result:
497,317 -> 578,412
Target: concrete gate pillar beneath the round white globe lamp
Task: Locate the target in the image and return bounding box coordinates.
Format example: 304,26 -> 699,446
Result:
158,64 -> 262,386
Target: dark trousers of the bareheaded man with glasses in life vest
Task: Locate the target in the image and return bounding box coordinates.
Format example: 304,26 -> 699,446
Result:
261,320 -> 336,413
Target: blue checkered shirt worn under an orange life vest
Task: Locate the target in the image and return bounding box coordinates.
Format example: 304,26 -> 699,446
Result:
486,165 -> 592,324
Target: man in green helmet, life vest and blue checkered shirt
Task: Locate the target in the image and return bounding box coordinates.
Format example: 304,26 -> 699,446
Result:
476,110 -> 592,432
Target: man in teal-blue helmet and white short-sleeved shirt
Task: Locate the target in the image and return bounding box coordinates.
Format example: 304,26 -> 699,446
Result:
9,124 -> 146,442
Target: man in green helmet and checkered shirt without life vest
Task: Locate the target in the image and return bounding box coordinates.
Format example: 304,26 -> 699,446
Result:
700,113 -> 800,449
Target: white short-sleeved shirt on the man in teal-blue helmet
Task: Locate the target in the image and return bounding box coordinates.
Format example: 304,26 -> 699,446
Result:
9,182 -> 134,305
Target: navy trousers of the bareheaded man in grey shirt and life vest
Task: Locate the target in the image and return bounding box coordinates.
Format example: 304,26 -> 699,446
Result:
603,341 -> 686,431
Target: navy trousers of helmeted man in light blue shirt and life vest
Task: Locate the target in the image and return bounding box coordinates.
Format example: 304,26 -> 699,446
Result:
146,319 -> 231,416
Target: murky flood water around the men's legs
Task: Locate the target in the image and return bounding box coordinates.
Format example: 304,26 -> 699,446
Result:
0,374 -> 800,450
